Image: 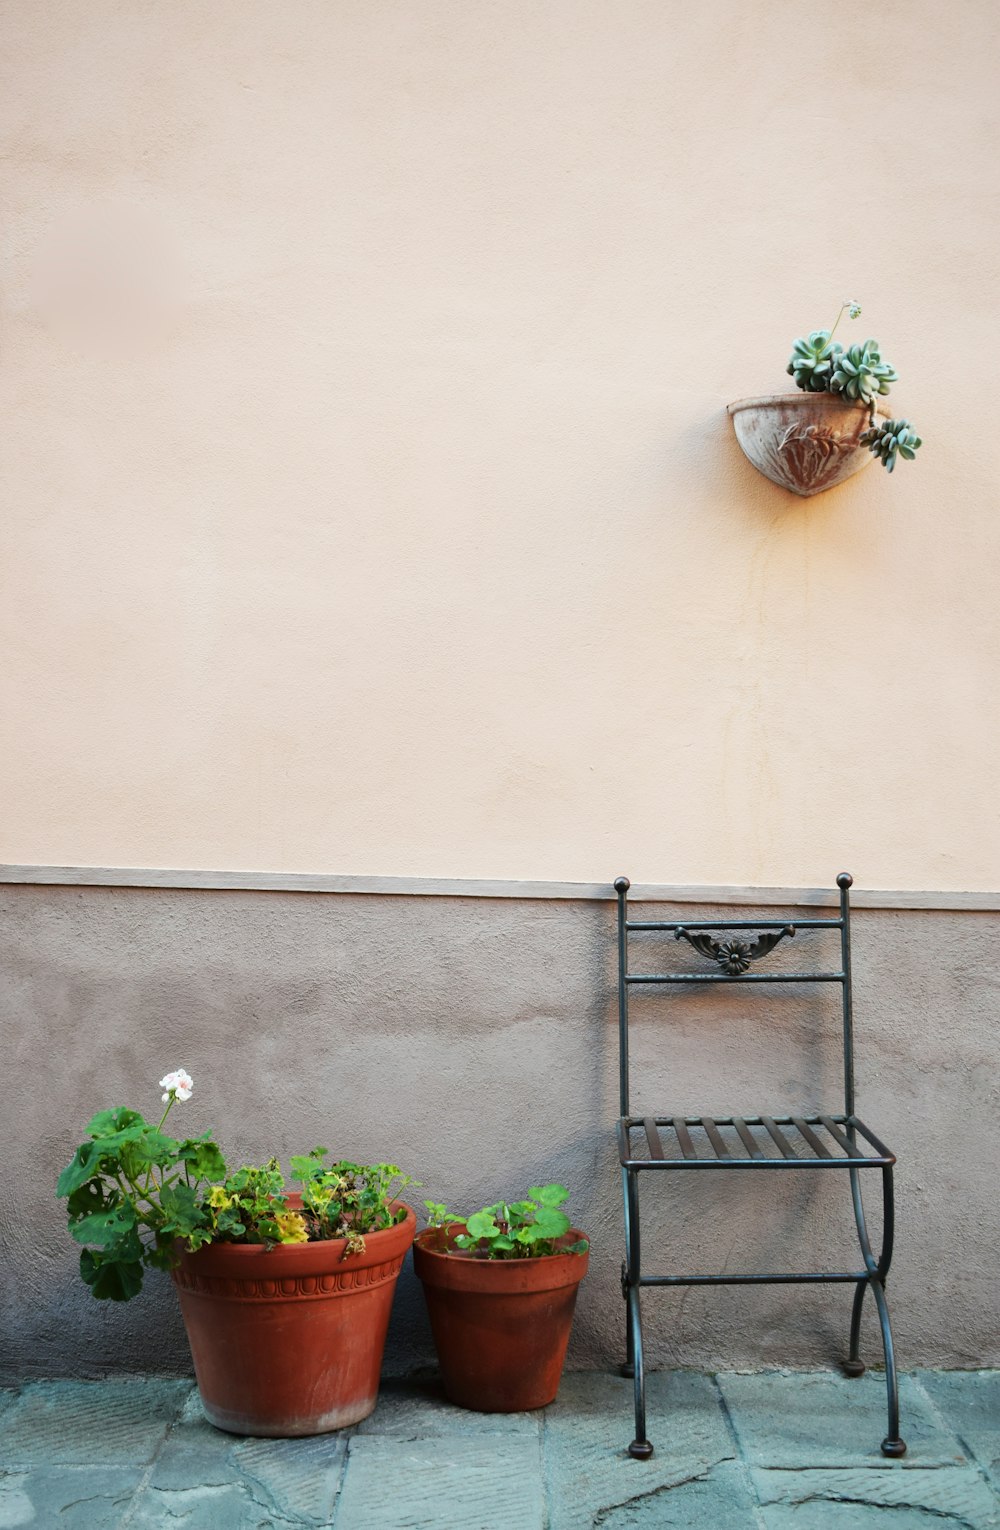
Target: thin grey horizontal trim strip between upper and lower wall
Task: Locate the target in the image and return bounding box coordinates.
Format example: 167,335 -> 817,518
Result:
0,864 -> 1000,913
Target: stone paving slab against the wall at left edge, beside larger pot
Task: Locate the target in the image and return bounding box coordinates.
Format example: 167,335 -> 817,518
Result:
0,1380 -> 191,1470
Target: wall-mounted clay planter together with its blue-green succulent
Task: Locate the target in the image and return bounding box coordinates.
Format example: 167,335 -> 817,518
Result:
729,301 -> 920,497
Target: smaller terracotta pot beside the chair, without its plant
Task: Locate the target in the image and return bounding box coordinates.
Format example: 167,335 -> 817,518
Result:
413,1222 -> 590,1414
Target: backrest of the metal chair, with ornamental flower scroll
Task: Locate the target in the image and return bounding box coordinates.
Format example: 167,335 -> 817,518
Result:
615,871 -> 855,1115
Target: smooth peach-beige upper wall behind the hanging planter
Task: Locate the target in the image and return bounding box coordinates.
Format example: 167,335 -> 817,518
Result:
0,0 -> 1000,889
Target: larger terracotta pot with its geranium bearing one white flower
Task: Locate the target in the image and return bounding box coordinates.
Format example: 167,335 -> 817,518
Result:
57,1068 -> 416,1435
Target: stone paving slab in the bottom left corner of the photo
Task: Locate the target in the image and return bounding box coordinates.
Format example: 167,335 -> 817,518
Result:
0,1466 -> 142,1530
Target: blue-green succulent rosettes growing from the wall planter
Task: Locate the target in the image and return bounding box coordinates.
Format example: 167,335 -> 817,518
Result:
786,300 -> 920,473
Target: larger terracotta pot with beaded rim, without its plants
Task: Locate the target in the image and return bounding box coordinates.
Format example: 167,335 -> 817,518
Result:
173,1207 -> 416,1437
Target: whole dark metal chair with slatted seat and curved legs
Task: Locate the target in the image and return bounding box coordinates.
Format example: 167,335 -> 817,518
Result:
615,872 -> 907,1460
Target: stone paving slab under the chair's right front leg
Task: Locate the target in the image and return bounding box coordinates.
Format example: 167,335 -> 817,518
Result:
719,1371 -> 966,1469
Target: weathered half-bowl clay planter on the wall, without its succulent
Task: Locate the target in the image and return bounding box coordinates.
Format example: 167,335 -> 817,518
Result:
728,393 -> 888,499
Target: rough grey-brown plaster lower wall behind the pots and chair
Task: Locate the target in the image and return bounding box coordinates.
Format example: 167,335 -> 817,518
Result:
0,886 -> 1000,1380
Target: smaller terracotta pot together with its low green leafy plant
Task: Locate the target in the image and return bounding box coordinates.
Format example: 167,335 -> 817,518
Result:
413,1184 -> 590,1414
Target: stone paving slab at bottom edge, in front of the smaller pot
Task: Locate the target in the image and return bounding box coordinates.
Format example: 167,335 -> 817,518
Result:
333,1431 -> 546,1530
